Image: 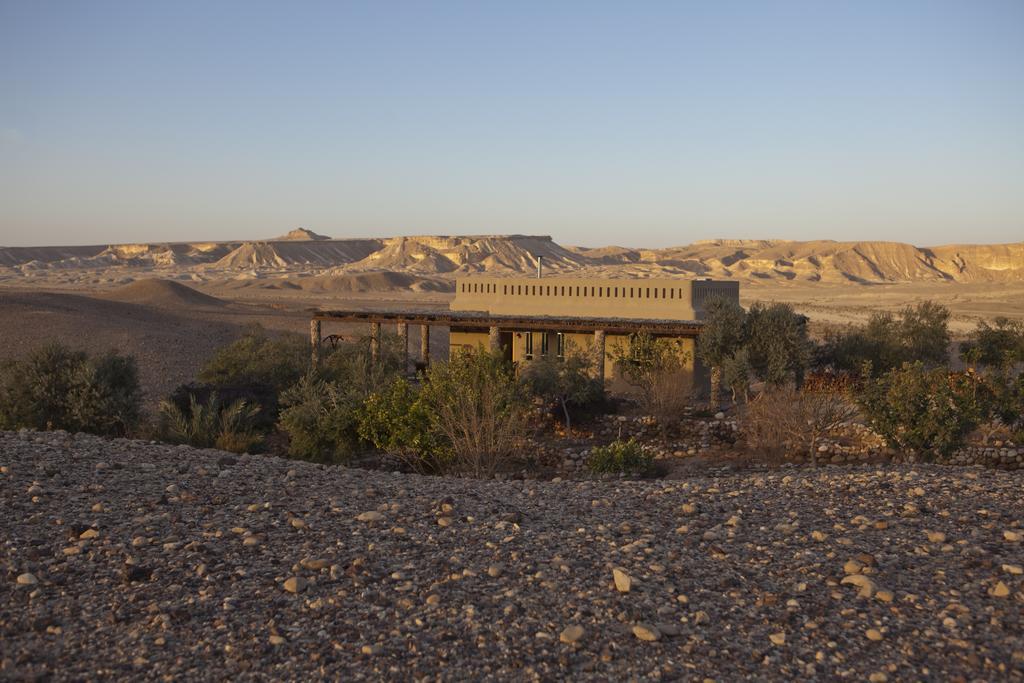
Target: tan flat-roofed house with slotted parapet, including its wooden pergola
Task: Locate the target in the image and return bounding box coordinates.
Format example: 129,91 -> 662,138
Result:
310,275 -> 739,389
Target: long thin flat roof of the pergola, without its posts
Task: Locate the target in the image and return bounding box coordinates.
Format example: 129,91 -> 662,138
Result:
310,309 -> 703,336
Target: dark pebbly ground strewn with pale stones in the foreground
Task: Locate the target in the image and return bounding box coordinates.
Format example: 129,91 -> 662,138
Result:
0,432 -> 1024,681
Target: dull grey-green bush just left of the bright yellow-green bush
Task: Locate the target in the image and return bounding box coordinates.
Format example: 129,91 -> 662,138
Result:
278,371 -> 364,463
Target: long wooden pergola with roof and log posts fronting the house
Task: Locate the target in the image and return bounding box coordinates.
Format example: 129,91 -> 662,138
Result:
309,309 -> 703,379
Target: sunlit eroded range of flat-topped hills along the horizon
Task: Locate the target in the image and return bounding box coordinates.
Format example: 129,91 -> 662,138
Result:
0,229 -> 1024,284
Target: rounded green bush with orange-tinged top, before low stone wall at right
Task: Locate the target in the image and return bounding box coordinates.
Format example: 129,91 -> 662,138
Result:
857,362 -> 992,455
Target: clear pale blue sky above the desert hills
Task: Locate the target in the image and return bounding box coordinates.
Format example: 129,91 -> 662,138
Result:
0,0 -> 1024,246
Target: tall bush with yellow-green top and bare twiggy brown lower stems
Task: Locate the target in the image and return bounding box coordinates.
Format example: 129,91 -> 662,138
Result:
422,348 -> 528,476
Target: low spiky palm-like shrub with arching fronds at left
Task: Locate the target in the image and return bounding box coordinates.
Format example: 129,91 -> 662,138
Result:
160,392 -> 262,453
